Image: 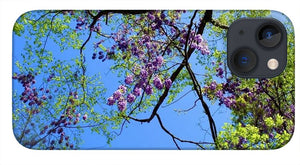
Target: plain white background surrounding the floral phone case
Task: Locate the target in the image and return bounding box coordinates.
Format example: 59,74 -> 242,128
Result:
0,0 -> 300,165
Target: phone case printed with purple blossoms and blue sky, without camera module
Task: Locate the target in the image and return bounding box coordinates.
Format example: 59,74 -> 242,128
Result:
12,10 -> 295,150
